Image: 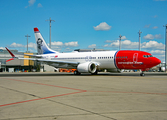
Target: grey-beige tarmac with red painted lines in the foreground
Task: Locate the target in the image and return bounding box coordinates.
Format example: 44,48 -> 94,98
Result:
0,73 -> 167,120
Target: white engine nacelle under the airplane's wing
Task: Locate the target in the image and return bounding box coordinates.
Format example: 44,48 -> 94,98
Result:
77,62 -> 97,73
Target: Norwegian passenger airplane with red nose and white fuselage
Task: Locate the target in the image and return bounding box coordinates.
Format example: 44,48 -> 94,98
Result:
6,28 -> 161,76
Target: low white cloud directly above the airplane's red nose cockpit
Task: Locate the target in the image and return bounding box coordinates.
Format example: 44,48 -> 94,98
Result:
141,41 -> 165,50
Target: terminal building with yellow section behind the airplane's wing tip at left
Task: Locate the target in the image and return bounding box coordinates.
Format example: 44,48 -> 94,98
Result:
0,49 -> 39,72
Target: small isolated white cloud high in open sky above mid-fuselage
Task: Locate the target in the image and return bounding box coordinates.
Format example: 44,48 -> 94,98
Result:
93,22 -> 112,31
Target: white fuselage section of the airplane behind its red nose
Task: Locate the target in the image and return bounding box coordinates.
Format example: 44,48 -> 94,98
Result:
42,51 -> 116,69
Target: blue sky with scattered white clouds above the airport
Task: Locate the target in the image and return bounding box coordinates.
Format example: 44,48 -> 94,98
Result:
0,0 -> 167,61
